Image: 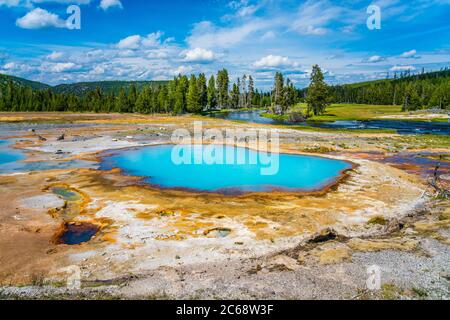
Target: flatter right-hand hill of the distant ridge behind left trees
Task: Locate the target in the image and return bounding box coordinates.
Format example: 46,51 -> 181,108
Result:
52,81 -> 168,96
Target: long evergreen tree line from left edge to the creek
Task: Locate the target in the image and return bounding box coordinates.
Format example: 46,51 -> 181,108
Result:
0,69 -> 274,114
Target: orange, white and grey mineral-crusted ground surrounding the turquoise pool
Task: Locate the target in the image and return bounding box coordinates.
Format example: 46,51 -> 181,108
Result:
0,114 -> 450,299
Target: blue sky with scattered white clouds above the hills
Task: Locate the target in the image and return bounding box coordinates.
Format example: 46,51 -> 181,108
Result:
0,0 -> 450,89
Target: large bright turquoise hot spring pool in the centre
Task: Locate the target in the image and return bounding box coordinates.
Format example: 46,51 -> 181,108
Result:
101,145 -> 351,193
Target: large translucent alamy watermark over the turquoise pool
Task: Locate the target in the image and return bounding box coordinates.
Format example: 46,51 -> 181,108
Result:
171,121 -> 280,176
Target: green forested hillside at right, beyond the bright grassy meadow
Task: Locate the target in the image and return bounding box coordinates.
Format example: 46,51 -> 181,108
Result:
324,69 -> 450,110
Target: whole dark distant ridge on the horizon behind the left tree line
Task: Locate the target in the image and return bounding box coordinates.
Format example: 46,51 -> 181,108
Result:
0,74 -> 168,96
